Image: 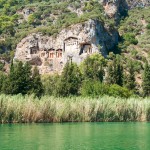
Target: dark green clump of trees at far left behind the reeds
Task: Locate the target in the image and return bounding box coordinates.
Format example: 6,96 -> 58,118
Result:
0,62 -> 43,97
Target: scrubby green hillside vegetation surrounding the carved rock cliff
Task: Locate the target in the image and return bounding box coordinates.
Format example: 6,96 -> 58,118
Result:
0,0 -> 150,89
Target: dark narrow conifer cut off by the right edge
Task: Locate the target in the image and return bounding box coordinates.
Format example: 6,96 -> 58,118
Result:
142,62 -> 150,96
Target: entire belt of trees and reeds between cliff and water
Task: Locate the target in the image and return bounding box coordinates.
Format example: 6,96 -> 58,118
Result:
0,54 -> 150,123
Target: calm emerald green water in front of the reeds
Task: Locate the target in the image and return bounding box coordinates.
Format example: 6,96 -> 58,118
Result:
0,123 -> 150,150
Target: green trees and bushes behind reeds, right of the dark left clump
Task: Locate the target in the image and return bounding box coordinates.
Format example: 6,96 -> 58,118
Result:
42,54 -> 150,98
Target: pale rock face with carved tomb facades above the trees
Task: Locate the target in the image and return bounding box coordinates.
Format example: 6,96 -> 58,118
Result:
15,20 -> 118,74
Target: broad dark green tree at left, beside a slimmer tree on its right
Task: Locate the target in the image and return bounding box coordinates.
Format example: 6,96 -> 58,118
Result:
3,61 -> 32,94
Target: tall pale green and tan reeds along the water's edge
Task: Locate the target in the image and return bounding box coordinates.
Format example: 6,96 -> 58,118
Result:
0,95 -> 150,123
